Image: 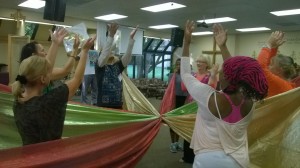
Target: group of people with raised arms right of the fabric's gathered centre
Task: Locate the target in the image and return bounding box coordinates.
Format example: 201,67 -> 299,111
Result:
166,21 -> 299,168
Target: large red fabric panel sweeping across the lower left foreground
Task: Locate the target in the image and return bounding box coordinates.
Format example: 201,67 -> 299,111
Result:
0,119 -> 161,168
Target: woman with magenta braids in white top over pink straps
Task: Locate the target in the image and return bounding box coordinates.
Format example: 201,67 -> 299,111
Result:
181,21 -> 268,168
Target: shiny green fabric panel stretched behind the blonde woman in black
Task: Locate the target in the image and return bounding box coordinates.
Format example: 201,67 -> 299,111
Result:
0,92 -> 159,149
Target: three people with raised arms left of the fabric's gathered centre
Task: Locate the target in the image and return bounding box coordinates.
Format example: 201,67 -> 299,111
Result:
12,23 -> 137,145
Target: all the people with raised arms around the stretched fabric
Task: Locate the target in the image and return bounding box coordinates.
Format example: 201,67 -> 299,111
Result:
8,17 -> 298,168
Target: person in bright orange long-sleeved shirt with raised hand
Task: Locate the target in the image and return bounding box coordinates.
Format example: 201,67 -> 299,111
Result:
258,31 -> 296,97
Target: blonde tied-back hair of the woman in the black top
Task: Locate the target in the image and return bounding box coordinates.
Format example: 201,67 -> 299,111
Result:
12,56 -> 50,98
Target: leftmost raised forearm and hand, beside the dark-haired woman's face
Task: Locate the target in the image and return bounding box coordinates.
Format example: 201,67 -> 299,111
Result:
46,28 -> 68,71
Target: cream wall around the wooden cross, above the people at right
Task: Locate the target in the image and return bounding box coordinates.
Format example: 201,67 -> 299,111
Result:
190,31 -> 300,67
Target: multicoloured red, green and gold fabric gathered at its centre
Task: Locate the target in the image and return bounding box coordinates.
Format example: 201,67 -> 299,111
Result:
0,75 -> 300,168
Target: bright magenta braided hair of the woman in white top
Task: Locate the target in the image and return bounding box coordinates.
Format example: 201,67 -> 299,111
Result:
223,56 -> 268,101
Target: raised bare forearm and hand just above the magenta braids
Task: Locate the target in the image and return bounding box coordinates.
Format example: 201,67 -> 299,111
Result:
213,24 -> 231,61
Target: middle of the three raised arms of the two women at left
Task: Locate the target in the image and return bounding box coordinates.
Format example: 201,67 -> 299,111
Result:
51,35 -> 80,80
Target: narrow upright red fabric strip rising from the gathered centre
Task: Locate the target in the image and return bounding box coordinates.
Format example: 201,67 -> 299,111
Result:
159,73 -> 176,114
